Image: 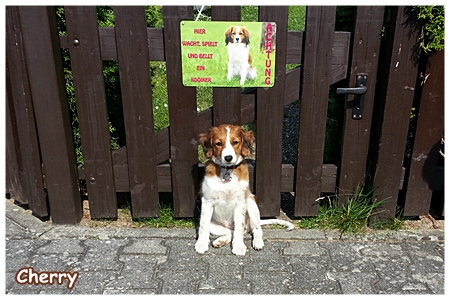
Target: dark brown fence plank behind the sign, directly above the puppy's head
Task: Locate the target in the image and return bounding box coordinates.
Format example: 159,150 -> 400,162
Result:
211,6 -> 241,126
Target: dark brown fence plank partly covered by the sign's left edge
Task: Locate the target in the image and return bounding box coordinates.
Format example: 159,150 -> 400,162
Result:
163,6 -> 199,217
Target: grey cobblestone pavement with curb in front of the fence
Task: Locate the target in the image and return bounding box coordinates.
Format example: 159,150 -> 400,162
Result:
4,202 -> 444,295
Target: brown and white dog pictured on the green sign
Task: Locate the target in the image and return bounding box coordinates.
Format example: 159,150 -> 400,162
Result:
225,26 -> 256,85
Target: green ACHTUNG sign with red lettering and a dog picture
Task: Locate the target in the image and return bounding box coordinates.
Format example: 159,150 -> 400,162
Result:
180,21 -> 277,87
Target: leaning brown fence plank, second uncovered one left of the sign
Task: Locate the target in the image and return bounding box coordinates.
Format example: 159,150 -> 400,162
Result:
65,6 -> 117,218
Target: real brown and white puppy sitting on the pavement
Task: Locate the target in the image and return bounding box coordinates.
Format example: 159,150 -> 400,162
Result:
195,124 -> 294,255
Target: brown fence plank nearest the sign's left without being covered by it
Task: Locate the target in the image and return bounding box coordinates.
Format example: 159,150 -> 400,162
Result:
114,6 -> 159,217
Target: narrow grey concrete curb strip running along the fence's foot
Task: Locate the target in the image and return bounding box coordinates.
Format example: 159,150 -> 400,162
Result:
5,199 -> 445,241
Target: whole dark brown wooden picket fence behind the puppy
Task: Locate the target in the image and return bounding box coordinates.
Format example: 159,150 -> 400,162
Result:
6,6 -> 444,224
